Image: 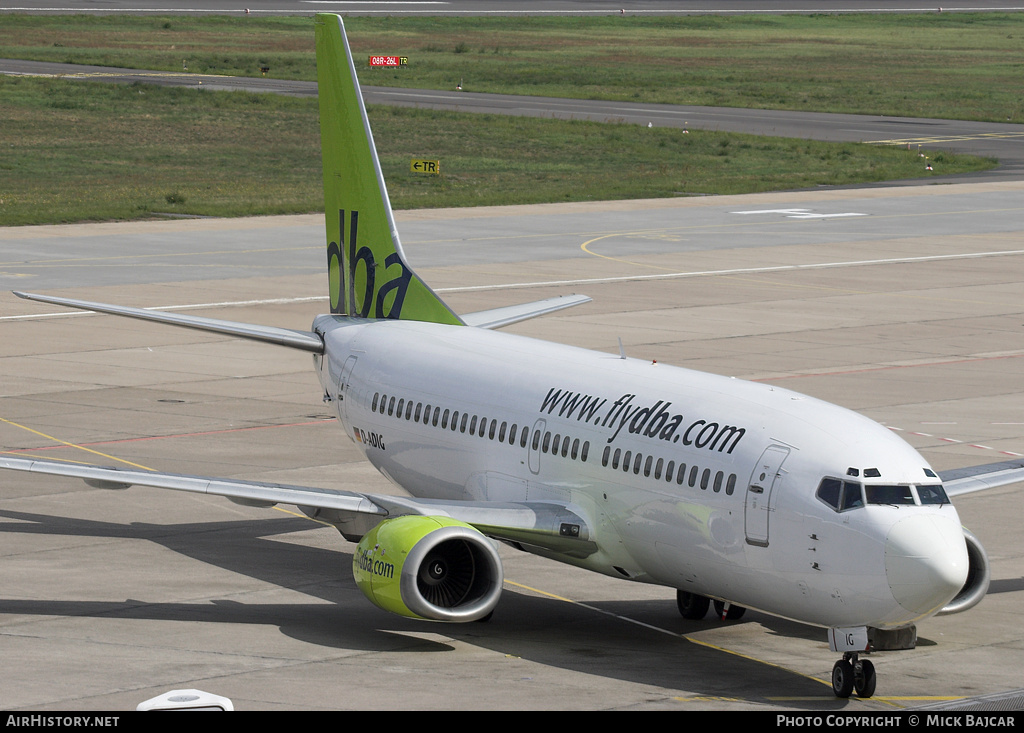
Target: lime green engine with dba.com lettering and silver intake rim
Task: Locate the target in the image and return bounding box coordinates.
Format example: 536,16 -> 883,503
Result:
352,515 -> 504,621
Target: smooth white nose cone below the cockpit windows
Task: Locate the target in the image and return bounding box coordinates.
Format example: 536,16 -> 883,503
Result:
886,514 -> 968,615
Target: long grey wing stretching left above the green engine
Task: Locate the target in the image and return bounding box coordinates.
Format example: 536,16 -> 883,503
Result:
0,456 -> 597,557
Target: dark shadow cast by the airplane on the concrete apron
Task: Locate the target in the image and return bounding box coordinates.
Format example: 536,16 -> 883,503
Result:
0,510 -> 848,709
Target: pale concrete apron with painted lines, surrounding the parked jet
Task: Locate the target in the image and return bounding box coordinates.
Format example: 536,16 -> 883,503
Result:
0,181 -> 1024,710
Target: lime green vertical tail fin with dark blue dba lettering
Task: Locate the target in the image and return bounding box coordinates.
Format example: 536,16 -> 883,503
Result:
315,13 -> 463,325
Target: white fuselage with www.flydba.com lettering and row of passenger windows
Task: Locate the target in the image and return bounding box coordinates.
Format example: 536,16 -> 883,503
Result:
313,316 -> 968,628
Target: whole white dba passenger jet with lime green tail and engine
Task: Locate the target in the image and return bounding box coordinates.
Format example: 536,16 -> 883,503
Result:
0,14 -> 1024,698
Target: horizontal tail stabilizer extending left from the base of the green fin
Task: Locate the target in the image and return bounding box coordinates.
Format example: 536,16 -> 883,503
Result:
14,291 -> 324,354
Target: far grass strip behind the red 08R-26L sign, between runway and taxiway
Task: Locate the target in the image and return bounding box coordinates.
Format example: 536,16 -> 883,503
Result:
0,13 -> 1024,122
